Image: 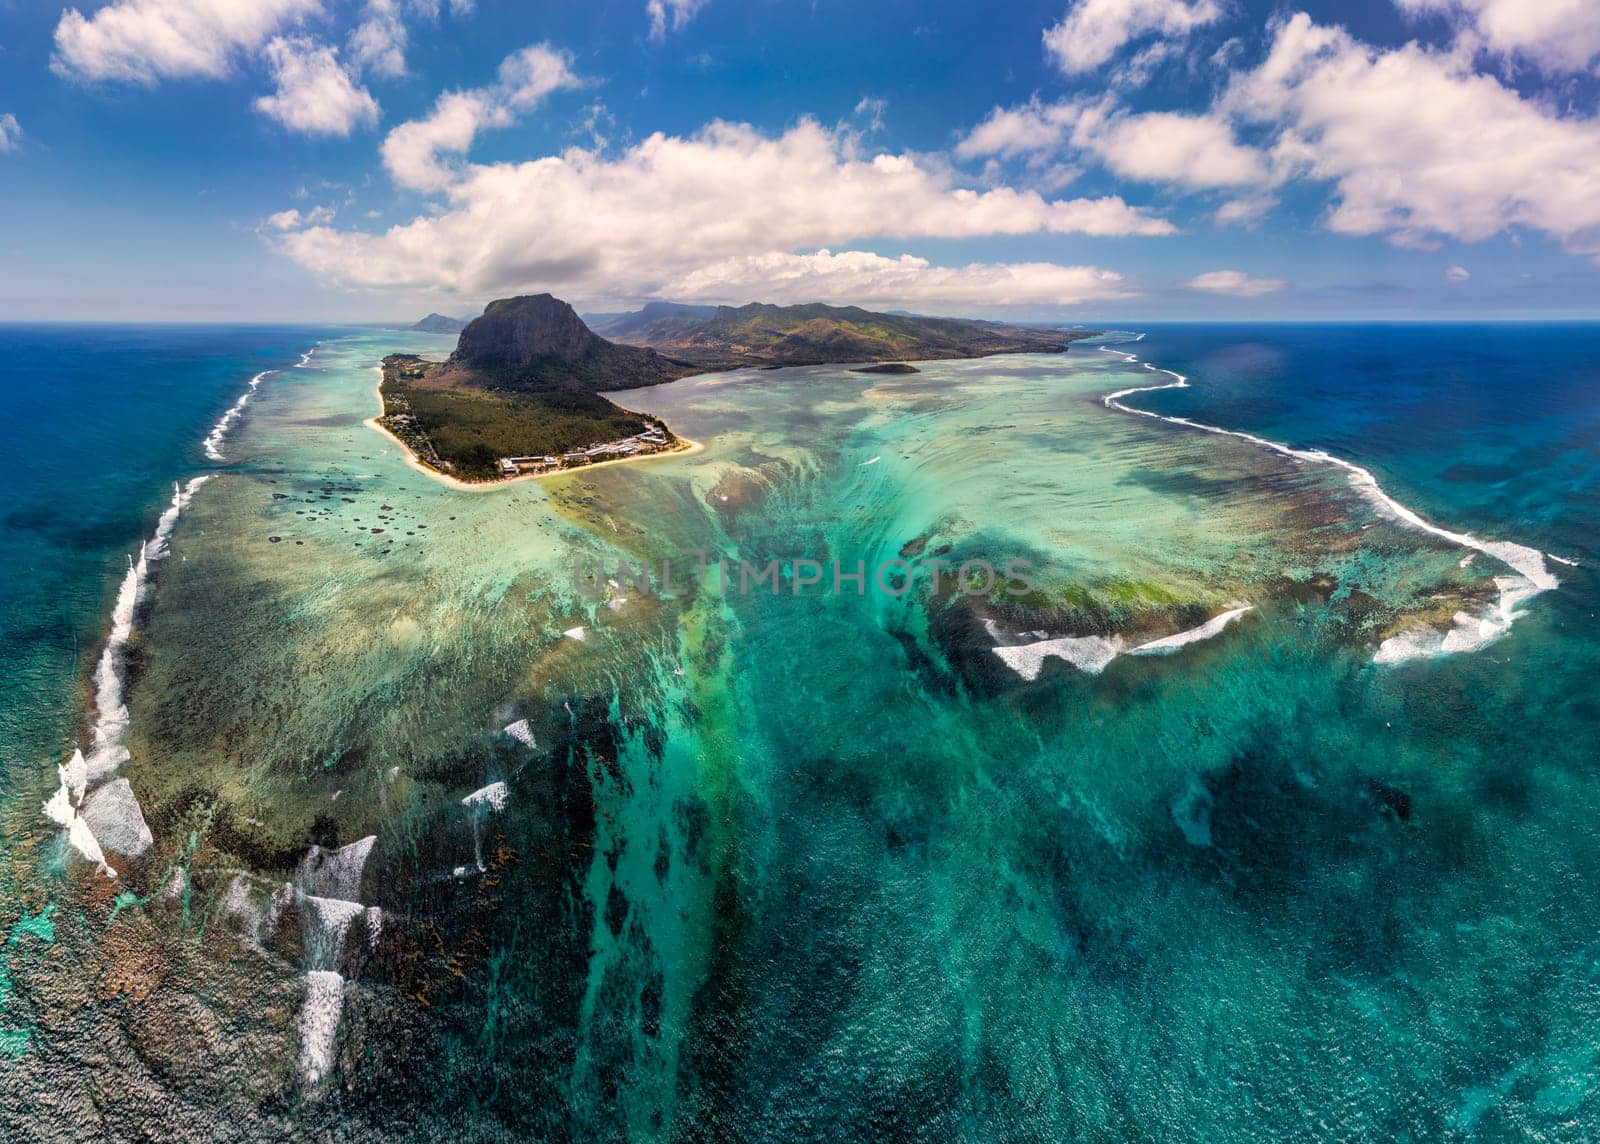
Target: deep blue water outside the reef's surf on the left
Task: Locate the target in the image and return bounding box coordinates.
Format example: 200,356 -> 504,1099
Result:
0,325 -> 328,800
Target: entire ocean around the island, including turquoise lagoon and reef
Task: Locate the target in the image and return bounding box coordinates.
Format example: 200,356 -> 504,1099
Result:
0,325 -> 1600,1141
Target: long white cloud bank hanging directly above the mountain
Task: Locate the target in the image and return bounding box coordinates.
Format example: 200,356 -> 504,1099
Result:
277,116 -> 1173,302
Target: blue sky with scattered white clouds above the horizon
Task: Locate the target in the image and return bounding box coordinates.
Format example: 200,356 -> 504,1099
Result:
0,0 -> 1600,322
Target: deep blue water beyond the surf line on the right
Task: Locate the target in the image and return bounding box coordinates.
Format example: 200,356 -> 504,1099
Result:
1130,323 -> 1600,557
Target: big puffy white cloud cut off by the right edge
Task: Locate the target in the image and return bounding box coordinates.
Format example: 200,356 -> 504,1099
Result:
1222,13 -> 1600,250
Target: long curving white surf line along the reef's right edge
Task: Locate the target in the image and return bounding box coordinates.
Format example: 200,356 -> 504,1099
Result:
1099,346 -> 1565,662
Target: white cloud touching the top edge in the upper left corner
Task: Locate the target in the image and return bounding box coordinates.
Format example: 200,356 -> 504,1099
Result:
50,0 -> 322,83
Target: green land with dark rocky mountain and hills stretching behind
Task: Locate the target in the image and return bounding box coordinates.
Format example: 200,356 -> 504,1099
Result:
379,294 -> 1091,480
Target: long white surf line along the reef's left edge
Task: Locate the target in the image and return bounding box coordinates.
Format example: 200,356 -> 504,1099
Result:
42,474 -> 211,877
